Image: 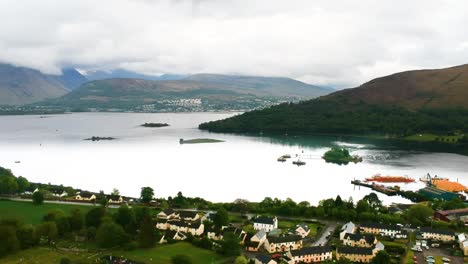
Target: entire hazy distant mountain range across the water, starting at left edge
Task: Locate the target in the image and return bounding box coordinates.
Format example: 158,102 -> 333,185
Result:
0,64 -> 334,107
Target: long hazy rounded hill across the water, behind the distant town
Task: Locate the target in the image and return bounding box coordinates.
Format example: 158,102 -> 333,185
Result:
40,74 -> 333,109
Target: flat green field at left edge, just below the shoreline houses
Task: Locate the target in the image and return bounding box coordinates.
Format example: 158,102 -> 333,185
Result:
0,200 -> 104,225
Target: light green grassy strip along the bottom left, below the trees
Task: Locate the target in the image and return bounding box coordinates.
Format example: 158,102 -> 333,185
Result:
0,243 -> 225,264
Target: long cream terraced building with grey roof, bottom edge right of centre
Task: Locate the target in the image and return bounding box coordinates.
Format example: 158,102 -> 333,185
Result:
286,246 -> 333,264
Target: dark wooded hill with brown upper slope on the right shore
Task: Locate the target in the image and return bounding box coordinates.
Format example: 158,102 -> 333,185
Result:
199,65 -> 468,137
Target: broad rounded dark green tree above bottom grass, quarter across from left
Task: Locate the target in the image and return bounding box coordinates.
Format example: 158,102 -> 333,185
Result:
96,222 -> 128,248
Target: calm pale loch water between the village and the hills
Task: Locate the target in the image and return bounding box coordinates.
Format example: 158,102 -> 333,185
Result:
0,113 -> 468,204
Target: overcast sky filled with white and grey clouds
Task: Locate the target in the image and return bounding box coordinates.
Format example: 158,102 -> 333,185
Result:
0,0 -> 468,88
